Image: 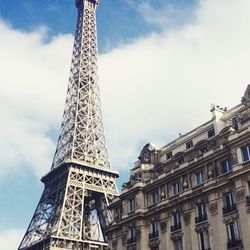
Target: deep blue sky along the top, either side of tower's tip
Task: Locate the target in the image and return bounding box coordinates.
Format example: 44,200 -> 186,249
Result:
0,0 -> 196,52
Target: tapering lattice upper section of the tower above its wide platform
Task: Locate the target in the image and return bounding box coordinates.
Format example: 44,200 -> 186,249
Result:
52,0 -> 110,169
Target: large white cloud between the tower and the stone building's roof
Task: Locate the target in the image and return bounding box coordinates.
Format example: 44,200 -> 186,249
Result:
100,0 -> 250,171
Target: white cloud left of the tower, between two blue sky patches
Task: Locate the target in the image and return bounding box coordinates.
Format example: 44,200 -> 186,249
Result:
0,22 -> 72,179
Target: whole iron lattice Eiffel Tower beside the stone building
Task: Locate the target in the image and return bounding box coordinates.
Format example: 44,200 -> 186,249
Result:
18,0 -> 118,250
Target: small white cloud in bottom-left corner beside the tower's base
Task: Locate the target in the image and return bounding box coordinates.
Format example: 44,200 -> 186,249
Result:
0,229 -> 24,250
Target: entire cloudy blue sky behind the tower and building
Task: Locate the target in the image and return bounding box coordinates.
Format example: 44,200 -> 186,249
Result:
0,0 -> 250,250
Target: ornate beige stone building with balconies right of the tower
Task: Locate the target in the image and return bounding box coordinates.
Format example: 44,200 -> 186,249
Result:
107,85 -> 250,250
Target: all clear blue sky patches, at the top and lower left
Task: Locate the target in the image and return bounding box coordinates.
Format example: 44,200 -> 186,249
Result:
0,0 -> 197,231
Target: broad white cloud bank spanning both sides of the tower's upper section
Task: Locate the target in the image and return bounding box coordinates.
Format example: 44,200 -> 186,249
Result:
0,0 -> 250,181
